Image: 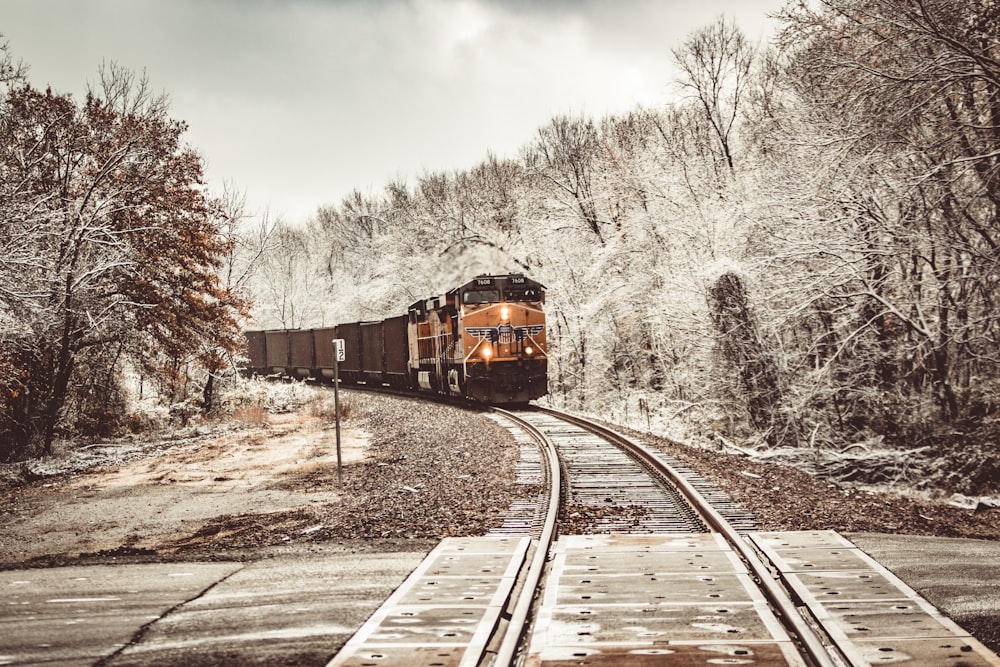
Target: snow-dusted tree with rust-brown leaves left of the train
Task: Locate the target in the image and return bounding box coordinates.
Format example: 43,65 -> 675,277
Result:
0,66 -> 241,456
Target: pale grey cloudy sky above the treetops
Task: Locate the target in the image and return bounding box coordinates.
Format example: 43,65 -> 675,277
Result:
0,0 -> 784,222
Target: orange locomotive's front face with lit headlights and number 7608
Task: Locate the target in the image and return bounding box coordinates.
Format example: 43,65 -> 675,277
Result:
457,275 -> 548,403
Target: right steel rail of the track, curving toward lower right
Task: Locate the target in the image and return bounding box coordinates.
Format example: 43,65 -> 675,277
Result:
534,406 -> 841,667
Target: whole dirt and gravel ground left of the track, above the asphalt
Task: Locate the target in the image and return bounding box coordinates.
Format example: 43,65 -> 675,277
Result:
0,392 -> 519,569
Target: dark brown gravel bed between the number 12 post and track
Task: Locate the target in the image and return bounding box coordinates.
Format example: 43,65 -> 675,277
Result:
160,392 -> 518,551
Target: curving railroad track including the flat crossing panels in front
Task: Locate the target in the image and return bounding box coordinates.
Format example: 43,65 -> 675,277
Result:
330,409 -> 1000,667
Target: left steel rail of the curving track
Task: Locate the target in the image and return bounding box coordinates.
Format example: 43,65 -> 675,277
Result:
492,407 -> 562,667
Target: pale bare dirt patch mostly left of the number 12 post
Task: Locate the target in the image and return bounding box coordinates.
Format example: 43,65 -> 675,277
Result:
0,413 -> 369,566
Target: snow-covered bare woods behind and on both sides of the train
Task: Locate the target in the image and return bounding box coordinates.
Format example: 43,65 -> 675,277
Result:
0,0 -> 1000,494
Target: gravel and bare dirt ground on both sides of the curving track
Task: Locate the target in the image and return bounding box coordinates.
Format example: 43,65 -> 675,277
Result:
0,392 -> 1000,567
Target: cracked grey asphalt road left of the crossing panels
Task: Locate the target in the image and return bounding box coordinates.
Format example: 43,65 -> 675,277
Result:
0,545 -> 429,667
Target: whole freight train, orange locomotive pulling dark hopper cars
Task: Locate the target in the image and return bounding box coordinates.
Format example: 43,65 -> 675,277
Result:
244,274 -> 548,405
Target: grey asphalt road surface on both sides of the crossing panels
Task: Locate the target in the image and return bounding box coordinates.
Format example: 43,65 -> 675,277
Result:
0,534 -> 1000,667
